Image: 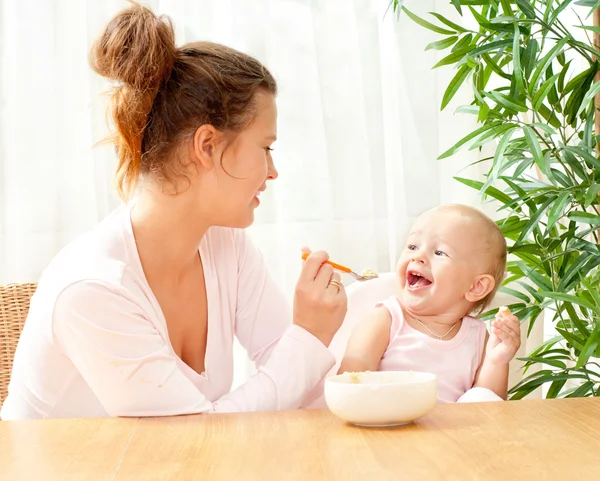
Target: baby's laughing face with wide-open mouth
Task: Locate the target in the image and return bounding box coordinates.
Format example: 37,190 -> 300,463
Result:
397,209 -> 490,317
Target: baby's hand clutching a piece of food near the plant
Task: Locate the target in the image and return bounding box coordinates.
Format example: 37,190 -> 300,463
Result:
486,307 -> 521,364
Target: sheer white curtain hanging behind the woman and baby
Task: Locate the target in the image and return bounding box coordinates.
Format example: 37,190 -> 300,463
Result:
0,0 -> 520,380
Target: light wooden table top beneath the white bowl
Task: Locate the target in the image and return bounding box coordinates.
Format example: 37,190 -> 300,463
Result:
0,398 -> 600,481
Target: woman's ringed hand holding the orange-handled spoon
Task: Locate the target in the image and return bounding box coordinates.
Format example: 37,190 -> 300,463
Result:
294,249 -> 348,346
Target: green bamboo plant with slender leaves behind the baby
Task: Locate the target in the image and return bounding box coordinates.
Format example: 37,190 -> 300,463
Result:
391,0 -> 600,399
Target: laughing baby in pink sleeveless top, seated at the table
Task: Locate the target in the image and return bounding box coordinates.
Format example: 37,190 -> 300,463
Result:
340,205 -> 521,403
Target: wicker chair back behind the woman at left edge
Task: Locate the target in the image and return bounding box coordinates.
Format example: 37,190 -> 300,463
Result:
0,283 -> 37,405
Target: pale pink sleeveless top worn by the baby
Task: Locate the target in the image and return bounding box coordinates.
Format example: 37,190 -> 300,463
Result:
379,297 -> 487,403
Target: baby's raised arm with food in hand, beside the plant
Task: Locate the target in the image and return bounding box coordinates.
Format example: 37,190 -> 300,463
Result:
473,308 -> 521,399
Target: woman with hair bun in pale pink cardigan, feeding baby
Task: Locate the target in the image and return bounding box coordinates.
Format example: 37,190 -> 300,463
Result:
0,4 -> 346,420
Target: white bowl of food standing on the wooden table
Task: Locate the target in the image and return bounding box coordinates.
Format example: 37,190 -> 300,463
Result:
325,371 -> 437,427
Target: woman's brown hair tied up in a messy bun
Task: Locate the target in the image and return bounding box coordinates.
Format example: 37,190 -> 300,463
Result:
90,2 -> 277,198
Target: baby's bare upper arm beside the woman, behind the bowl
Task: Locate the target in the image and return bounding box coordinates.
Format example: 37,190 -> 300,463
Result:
339,307 -> 392,374
